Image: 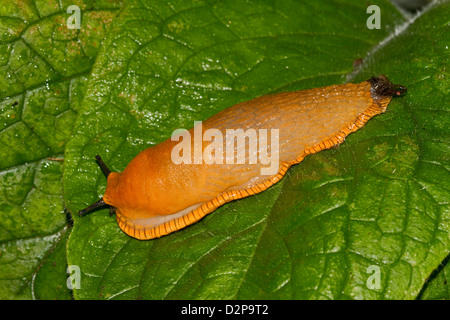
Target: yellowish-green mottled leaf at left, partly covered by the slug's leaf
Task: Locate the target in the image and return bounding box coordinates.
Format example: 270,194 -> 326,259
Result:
0,0 -> 120,299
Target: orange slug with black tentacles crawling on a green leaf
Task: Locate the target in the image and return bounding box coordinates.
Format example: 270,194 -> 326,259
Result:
79,75 -> 406,240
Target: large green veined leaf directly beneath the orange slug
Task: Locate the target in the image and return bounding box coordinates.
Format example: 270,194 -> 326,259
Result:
64,1 -> 450,299
